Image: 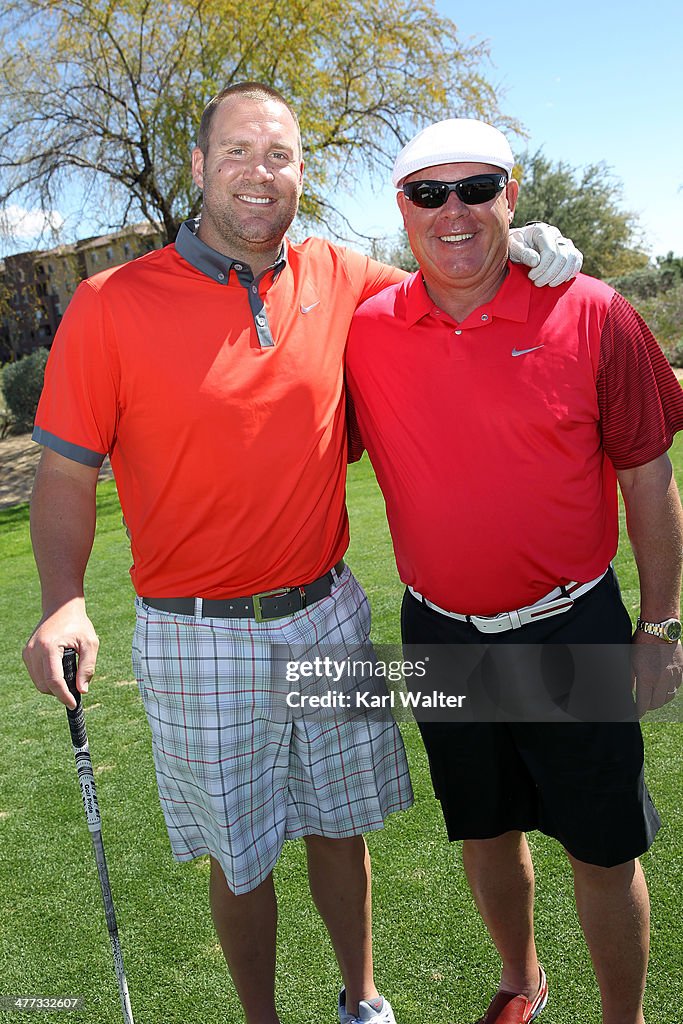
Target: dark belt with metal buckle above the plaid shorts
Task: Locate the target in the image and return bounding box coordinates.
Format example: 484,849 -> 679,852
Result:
142,558 -> 344,623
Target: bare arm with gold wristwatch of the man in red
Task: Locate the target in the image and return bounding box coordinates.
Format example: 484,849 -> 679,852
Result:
617,455 -> 683,717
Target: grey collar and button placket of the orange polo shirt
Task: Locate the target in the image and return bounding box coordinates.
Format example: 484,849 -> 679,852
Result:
175,220 -> 287,348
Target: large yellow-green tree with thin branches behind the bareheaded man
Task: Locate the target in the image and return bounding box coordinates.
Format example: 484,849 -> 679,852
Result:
0,0 -> 512,240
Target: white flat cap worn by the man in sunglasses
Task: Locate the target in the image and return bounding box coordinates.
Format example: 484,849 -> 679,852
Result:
391,118 -> 515,188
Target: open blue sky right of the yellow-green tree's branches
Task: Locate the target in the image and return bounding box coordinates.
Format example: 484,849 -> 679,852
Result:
335,0 -> 683,256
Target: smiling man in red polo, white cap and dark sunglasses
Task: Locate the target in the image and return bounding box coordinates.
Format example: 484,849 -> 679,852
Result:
347,120 -> 683,1024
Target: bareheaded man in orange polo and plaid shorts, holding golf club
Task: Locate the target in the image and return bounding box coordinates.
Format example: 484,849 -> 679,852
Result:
20,83 -> 575,1024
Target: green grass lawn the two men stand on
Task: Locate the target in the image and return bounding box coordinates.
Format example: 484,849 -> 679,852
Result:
0,444 -> 683,1024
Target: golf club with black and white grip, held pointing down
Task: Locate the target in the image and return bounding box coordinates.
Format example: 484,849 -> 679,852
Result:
61,647 -> 134,1024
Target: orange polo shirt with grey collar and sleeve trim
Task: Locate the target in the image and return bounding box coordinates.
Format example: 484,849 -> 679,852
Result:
34,225 -> 404,598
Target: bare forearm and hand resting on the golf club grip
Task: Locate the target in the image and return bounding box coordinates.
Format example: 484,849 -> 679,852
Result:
24,449 -> 99,708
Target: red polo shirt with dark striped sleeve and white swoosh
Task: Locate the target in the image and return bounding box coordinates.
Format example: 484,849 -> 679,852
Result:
347,265 -> 683,615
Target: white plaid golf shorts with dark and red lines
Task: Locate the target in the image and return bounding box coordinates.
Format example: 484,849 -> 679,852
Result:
133,567 -> 413,895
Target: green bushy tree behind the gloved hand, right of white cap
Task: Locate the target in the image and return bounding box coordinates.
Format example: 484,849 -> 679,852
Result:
514,153 -> 647,279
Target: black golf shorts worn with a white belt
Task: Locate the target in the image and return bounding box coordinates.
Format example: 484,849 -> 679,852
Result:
401,570 -> 660,867
